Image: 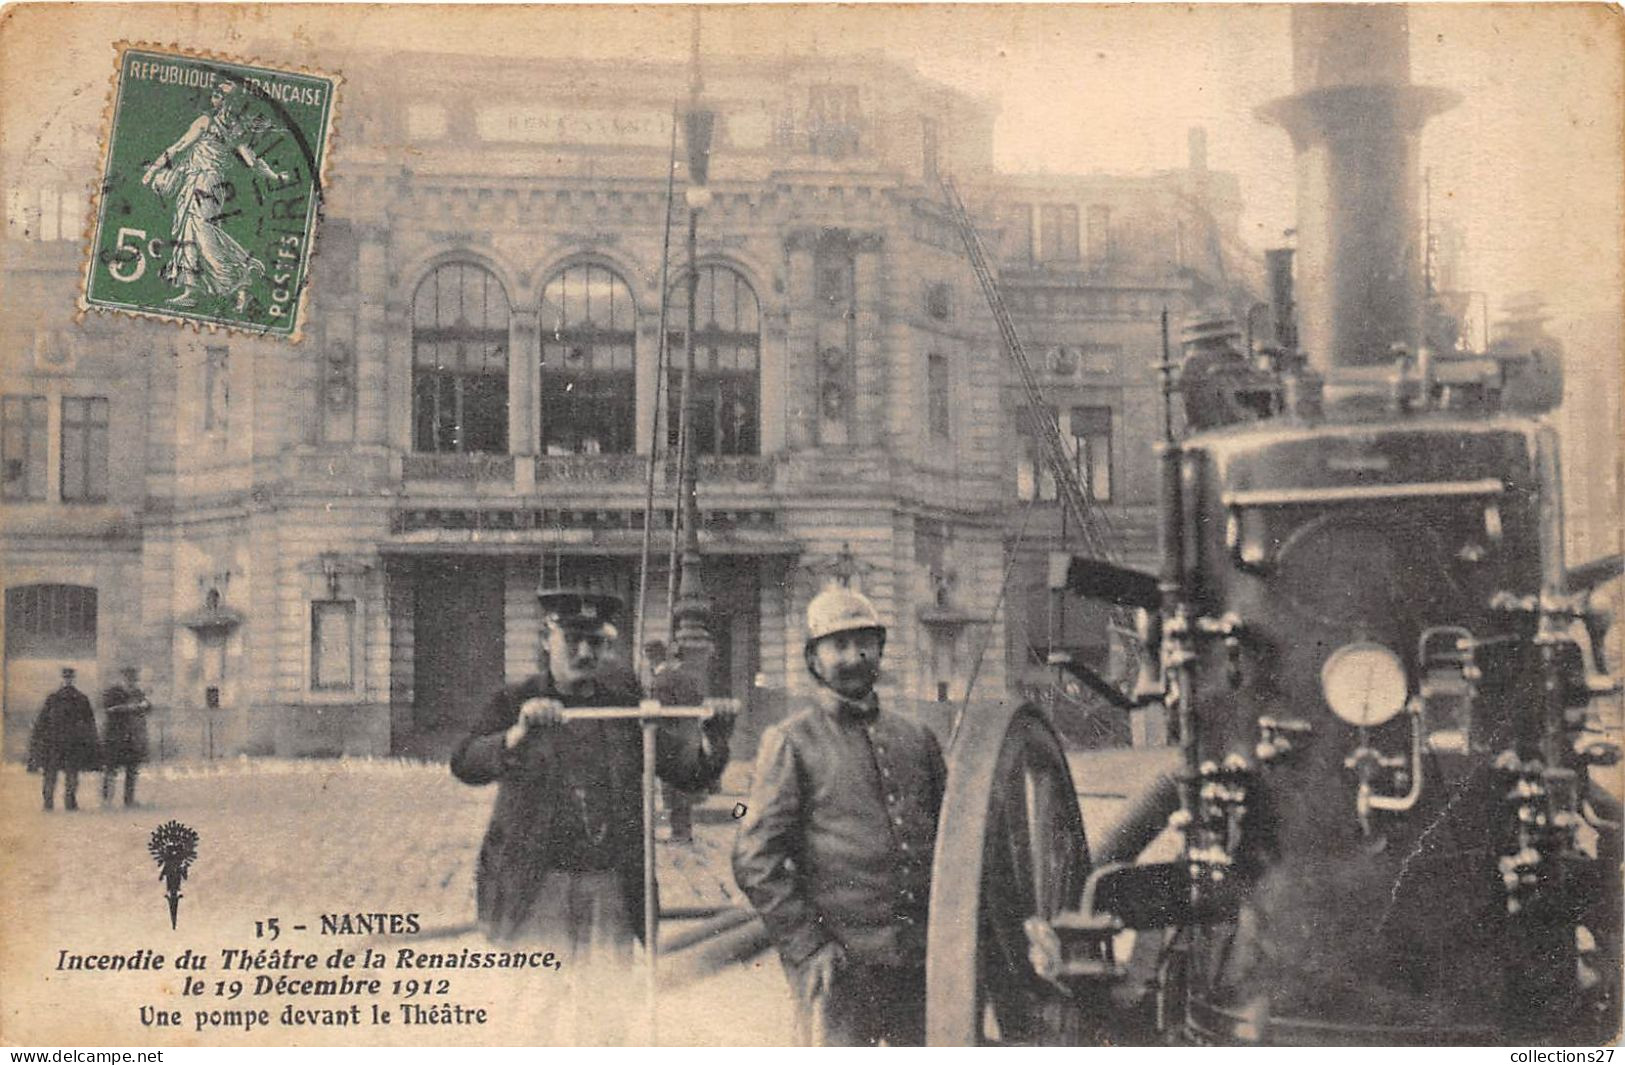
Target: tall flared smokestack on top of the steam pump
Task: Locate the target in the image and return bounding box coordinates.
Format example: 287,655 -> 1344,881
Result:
1259,3 -> 1456,372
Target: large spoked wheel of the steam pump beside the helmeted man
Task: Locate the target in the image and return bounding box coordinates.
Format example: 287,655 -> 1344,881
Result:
926,706 -> 1090,1045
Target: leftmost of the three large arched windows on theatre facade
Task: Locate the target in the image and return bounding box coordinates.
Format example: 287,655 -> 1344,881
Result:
411,262 -> 509,452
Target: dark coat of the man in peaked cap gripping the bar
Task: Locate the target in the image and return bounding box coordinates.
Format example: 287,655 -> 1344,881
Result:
452,670 -> 728,940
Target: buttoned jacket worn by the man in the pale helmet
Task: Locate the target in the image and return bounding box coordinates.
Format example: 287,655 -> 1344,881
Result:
733,693 -> 947,966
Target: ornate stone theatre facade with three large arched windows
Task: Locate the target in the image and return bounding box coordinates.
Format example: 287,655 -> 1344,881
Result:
0,45 -> 1254,758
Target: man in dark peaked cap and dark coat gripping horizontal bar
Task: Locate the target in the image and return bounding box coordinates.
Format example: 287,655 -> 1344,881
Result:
452,590 -> 733,1044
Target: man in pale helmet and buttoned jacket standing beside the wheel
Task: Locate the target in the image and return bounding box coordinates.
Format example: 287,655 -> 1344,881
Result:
733,587 -> 947,1045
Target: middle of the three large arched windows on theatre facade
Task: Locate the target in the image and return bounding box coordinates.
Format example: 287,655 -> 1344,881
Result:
541,263 -> 637,455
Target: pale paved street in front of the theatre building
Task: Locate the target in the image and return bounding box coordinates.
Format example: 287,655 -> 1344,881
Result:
0,751 -> 1167,1045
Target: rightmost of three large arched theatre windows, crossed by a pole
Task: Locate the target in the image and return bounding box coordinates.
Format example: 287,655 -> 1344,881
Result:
666,265 -> 762,455
